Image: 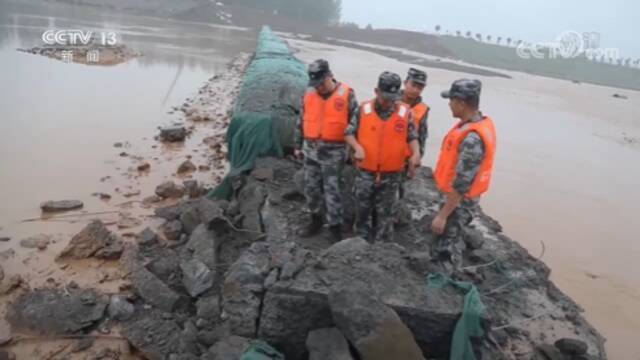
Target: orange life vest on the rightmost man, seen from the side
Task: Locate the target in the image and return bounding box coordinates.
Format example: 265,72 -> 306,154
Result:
434,116 -> 496,199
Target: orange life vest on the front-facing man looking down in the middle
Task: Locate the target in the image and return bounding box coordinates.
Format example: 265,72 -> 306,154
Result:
357,100 -> 409,173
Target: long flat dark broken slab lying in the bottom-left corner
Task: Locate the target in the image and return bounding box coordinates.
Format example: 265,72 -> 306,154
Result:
7,289 -> 108,335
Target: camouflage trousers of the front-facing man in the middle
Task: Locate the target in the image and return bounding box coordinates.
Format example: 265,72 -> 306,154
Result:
354,170 -> 401,241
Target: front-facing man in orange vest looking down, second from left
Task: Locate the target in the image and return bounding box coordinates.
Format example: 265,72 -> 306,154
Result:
345,72 -> 420,241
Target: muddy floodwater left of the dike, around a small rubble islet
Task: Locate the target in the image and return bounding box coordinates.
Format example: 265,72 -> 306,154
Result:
0,2 -> 255,238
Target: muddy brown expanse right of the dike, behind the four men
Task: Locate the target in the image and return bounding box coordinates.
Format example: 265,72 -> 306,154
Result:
290,40 -> 640,360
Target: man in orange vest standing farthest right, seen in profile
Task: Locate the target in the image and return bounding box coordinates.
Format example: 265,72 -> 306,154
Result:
431,79 -> 496,268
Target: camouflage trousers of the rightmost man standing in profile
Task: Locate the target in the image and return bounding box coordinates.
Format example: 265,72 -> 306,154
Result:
431,205 -> 473,268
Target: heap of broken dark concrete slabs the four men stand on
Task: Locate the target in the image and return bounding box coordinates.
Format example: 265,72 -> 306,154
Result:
7,29 -> 606,360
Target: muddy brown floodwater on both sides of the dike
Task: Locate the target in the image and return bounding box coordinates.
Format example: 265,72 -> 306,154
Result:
0,1 -> 640,360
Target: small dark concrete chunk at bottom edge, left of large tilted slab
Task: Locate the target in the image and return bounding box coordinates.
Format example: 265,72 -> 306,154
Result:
306,328 -> 353,360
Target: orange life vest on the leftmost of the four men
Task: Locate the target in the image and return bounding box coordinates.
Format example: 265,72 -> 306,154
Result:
302,84 -> 350,142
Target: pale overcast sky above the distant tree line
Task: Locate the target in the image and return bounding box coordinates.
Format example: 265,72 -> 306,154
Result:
342,0 -> 640,58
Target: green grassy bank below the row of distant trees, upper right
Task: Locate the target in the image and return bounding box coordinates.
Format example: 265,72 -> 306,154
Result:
438,35 -> 640,90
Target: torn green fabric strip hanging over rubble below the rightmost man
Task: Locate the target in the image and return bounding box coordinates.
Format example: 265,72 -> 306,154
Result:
427,274 -> 485,360
